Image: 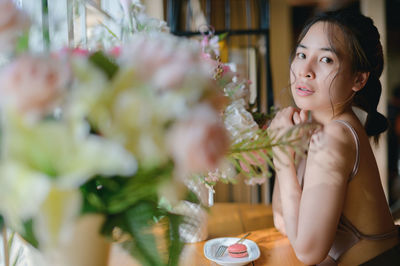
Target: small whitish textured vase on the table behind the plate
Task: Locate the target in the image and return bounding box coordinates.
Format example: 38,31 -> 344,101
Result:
177,180 -> 209,243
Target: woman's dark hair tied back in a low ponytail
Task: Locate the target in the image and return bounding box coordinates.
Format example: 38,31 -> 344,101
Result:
290,10 -> 388,142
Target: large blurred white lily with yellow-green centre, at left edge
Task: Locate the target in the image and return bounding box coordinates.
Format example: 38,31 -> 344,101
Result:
1,114 -> 137,188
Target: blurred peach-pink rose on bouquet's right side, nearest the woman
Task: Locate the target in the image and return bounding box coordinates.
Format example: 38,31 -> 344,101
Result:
168,105 -> 229,174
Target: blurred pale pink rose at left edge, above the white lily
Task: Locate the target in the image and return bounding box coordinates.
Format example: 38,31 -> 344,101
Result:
0,55 -> 69,115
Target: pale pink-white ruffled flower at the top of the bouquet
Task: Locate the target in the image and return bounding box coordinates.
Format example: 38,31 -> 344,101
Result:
119,34 -> 207,91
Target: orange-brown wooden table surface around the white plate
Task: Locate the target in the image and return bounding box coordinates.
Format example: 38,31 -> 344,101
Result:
109,203 -> 304,266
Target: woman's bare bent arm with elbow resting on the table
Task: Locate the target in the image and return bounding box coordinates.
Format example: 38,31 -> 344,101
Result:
277,123 -> 355,264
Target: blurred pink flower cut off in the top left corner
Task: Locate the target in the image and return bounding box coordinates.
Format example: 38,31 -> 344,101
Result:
0,0 -> 29,52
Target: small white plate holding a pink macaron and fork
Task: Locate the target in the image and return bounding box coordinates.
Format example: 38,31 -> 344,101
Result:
204,237 -> 260,266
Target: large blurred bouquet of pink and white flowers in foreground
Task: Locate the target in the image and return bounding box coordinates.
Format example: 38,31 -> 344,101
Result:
0,0 -> 229,265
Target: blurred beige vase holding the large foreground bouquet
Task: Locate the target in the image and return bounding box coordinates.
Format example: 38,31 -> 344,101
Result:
42,214 -> 110,266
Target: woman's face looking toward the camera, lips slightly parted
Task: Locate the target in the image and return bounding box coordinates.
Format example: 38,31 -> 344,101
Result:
290,22 -> 355,116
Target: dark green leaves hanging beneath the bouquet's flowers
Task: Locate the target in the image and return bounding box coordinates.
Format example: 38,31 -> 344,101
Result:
81,162 -> 180,265
